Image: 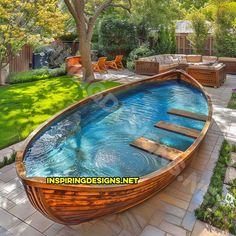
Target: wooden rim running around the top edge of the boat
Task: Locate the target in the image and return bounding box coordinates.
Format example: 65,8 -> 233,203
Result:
16,70 -> 213,191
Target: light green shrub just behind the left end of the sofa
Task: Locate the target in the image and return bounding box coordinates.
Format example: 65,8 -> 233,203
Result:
127,44 -> 155,70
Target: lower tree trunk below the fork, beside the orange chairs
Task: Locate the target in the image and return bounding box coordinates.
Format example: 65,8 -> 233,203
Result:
79,39 -> 95,82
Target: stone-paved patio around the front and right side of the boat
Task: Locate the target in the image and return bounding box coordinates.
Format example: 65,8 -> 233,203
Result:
0,76 -> 236,236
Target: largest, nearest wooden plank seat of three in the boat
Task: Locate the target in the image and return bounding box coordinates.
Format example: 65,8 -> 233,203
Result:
130,137 -> 183,161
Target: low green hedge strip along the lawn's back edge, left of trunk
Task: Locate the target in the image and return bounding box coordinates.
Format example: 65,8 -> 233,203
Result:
7,65 -> 66,84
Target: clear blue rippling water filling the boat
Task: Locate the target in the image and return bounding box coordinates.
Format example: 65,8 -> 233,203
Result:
24,80 -> 208,177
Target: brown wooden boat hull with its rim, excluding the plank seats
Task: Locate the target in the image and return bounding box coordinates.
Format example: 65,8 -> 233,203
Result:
16,71 -> 212,224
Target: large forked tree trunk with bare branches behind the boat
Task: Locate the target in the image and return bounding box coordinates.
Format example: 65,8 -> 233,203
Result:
64,0 -> 131,81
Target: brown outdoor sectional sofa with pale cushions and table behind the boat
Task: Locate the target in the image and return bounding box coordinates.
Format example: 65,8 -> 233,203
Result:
135,54 -> 236,88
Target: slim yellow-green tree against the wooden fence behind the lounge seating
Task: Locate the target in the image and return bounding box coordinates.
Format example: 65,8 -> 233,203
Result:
188,11 -> 209,54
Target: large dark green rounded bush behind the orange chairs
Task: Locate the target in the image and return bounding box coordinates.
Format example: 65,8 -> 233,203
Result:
99,17 -> 138,56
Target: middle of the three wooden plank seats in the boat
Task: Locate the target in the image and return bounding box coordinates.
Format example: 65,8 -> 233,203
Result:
155,121 -> 200,138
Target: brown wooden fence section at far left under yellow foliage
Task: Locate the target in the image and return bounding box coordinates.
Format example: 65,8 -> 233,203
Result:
9,45 -> 33,73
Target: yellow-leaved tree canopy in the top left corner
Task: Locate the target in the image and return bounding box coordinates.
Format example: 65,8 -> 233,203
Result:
0,0 -> 67,84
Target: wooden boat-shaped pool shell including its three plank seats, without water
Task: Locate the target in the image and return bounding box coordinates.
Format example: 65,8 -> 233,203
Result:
16,70 -> 212,224
